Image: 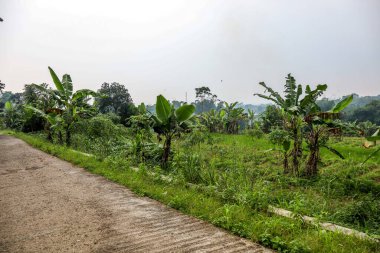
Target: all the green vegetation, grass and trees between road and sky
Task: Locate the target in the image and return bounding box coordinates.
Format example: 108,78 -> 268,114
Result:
1,68 -> 380,252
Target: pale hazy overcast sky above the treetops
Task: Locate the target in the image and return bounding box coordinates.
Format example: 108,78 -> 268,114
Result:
0,0 -> 380,104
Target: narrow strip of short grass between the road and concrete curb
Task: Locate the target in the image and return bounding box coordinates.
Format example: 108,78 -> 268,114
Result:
0,131 -> 380,252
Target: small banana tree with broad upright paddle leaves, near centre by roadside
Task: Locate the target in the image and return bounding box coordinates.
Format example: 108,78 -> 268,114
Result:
152,95 -> 195,168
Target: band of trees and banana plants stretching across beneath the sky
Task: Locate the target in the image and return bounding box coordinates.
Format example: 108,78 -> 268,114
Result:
0,67 -> 380,176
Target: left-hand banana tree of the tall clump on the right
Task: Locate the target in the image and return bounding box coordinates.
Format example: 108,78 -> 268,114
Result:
254,74 -> 327,175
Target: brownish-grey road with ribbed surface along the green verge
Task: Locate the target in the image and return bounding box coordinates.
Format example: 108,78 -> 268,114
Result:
0,136 -> 270,252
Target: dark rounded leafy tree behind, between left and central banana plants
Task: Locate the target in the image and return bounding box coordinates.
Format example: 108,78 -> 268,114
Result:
95,82 -> 137,124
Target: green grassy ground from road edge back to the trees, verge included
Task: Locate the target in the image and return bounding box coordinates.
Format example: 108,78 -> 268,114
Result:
2,132 -> 380,252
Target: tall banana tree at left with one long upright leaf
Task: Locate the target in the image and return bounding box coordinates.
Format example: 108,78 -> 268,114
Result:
35,67 -> 98,146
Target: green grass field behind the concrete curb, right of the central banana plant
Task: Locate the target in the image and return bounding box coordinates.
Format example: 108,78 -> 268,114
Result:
177,134 -> 380,235
